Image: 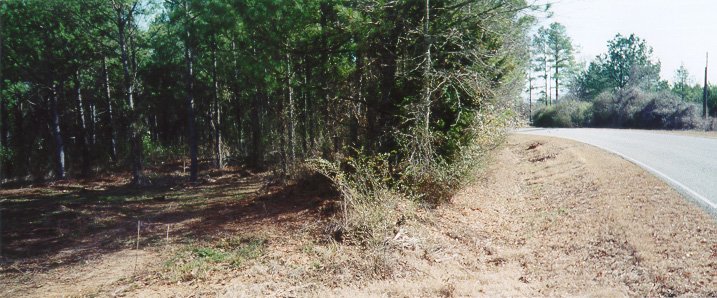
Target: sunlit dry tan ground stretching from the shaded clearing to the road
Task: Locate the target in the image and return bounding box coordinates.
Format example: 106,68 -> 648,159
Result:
0,134 -> 717,297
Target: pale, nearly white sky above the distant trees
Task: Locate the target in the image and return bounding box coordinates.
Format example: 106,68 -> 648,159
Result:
541,0 -> 717,83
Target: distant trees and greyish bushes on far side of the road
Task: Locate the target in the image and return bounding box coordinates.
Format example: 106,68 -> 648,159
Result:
526,23 -> 717,130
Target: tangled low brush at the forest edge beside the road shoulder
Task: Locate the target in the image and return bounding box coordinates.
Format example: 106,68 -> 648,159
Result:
308,108 -> 514,251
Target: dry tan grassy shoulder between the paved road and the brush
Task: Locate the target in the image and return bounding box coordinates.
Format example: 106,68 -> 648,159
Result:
326,134 -> 717,297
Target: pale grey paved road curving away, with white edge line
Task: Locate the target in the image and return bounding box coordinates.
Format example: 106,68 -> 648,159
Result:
517,128 -> 717,213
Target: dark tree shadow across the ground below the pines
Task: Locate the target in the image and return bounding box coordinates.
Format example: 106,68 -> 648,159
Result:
0,171 -> 338,272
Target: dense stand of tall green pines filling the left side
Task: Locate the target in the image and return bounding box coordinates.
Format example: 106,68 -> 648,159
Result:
0,0 -> 544,198
